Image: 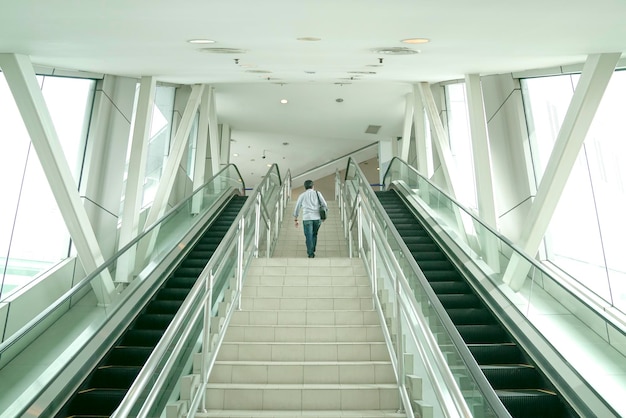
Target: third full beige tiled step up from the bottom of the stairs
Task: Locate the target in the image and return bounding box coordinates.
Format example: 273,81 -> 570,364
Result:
217,341 -> 389,361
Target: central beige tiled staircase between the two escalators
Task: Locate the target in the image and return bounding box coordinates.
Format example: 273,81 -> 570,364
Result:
196,202 -> 406,418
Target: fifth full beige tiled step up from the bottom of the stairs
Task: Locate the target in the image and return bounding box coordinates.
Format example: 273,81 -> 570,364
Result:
230,310 -> 380,325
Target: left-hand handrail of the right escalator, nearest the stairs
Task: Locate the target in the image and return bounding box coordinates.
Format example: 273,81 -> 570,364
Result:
346,159 -> 510,417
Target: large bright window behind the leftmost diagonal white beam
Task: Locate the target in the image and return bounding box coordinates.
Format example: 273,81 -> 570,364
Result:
0,73 -> 95,299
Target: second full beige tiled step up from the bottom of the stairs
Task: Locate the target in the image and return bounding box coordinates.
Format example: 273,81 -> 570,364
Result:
211,361 -> 396,385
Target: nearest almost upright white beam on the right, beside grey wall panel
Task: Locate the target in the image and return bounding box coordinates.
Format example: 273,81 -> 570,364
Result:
465,74 -> 496,228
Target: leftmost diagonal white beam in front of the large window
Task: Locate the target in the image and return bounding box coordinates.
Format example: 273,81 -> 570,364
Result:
0,54 -> 115,305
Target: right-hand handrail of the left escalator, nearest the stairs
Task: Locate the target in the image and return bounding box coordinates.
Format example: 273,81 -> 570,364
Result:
112,164 -> 282,417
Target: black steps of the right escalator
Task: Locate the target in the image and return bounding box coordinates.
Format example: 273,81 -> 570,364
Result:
376,191 -> 577,418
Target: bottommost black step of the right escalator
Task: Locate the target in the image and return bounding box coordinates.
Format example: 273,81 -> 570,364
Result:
496,389 -> 567,418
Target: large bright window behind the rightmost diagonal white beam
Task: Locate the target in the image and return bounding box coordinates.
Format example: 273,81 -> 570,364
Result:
522,71 -> 626,312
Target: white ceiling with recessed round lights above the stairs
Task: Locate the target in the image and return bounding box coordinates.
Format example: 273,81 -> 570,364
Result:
0,0 -> 626,186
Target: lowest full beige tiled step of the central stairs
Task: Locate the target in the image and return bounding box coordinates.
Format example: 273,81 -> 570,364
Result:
206,383 -> 400,411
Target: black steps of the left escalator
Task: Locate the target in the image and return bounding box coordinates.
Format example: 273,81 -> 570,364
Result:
56,196 -> 246,418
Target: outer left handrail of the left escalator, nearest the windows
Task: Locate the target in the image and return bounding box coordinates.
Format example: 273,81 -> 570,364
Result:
0,164 -> 245,356
